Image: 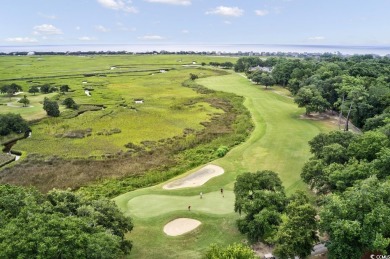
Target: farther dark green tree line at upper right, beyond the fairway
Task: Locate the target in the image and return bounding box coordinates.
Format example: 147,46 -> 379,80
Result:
234,55 -> 390,130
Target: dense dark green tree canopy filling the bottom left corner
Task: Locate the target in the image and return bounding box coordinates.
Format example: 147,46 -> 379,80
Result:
0,185 -> 133,258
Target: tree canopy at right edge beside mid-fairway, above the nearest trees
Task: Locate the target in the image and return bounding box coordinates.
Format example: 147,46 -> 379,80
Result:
301,131 -> 390,194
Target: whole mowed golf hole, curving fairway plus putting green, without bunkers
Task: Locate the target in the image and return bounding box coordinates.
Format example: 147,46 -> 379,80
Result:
114,74 -> 332,258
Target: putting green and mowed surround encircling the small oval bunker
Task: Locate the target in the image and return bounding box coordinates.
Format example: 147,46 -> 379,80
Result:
115,183 -> 244,259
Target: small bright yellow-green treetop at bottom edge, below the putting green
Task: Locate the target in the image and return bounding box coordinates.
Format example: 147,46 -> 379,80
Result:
203,243 -> 258,259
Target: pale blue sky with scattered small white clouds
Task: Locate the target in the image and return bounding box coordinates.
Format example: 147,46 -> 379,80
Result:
0,0 -> 390,46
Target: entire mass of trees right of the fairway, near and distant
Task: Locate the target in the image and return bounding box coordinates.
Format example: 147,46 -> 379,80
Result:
230,55 -> 390,258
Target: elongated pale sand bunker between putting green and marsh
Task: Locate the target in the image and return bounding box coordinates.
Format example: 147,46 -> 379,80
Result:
163,165 -> 224,190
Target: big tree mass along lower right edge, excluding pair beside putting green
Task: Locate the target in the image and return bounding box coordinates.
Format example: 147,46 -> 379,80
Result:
301,125 -> 390,259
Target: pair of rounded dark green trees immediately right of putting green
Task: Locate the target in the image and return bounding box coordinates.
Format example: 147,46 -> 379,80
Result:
234,170 -> 318,258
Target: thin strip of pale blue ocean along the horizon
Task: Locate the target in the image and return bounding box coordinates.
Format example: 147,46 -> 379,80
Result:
0,44 -> 390,56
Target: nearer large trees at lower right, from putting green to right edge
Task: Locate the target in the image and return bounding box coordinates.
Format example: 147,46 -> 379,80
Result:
225,125 -> 390,259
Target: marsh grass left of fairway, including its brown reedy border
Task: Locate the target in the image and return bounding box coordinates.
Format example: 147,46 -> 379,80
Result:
0,56 -> 251,197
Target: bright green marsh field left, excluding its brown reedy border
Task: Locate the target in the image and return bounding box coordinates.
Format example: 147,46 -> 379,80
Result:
0,55 -> 234,159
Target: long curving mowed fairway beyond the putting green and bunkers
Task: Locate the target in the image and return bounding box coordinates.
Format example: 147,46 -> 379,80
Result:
198,74 -> 327,192
